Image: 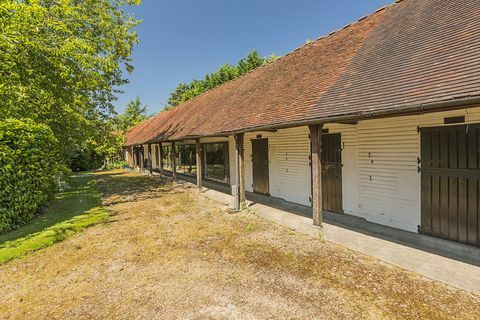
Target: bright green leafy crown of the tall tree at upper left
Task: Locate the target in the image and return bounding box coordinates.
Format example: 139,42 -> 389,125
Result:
0,0 -> 140,163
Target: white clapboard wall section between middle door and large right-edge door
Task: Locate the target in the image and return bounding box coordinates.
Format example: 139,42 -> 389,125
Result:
354,108 -> 480,232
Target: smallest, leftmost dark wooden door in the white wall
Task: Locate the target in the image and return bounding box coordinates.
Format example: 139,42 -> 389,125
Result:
252,139 -> 270,195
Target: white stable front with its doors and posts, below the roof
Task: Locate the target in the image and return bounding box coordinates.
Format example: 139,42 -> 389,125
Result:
128,106 -> 480,247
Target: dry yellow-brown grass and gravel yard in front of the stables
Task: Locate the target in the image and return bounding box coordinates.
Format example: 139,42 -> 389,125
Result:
0,170 -> 480,319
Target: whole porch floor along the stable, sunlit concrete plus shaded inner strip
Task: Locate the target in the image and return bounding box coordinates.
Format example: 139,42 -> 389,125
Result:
135,169 -> 480,292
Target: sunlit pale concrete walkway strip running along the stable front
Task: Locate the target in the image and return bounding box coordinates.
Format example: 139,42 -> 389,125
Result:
194,184 -> 480,294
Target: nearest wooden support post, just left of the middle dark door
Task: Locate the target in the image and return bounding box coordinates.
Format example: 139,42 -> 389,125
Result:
308,124 -> 323,226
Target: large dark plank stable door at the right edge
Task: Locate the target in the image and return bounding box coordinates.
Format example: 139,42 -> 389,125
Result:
419,124 -> 480,246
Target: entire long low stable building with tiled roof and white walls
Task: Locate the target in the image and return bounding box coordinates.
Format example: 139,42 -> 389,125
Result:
126,0 -> 480,246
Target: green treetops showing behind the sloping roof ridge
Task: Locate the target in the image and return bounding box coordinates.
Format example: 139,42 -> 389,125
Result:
167,50 -> 277,109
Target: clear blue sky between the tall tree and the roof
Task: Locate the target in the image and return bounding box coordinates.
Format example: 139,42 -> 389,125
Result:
115,0 -> 393,114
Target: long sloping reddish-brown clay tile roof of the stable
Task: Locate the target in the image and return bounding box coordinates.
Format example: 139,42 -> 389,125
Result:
127,0 -> 480,145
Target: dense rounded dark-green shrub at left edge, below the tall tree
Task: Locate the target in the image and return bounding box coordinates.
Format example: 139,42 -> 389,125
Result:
0,119 -> 60,233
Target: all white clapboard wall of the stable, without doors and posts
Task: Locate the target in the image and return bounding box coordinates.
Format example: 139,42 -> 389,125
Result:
238,107 -> 480,232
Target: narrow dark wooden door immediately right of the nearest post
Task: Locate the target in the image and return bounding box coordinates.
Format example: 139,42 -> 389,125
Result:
321,133 -> 343,213
